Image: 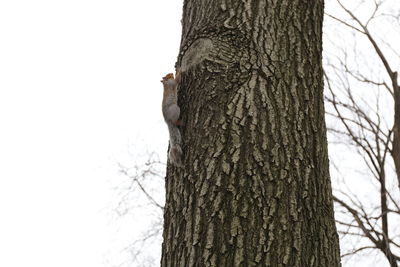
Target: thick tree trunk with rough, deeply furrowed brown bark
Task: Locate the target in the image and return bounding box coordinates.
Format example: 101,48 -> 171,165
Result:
161,0 -> 340,267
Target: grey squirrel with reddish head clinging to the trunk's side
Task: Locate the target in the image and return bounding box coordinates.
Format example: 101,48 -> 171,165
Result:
161,70 -> 183,167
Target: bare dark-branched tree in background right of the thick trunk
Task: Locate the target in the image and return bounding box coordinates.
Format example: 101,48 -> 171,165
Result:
325,0 -> 400,267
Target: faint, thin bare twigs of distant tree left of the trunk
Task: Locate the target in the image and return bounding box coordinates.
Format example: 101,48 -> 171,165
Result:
113,155 -> 166,267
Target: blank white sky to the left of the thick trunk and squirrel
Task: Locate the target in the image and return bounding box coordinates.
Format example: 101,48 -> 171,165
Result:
0,0 -> 182,267
